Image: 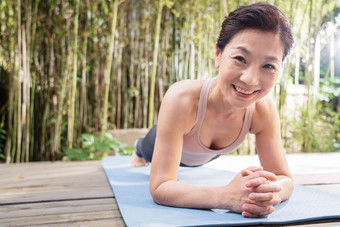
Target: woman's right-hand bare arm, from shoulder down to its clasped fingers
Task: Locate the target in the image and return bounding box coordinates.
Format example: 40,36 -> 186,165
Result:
244,97 -> 294,217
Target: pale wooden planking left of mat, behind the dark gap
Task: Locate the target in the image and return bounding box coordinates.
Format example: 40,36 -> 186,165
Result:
0,161 -> 113,205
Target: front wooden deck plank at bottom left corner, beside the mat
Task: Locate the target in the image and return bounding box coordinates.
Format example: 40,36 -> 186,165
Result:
0,198 -> 124,226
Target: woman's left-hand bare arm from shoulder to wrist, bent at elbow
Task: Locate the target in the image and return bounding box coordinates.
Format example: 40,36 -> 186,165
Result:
150,82 -> 226,208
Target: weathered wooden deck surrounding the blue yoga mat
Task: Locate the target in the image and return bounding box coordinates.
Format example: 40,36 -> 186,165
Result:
0,152 -> 340,226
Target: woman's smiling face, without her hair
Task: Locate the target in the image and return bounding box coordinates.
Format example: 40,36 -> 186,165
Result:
215,29 -> 284,108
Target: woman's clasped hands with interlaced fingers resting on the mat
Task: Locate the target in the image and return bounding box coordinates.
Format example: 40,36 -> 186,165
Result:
229,167 -> 282,218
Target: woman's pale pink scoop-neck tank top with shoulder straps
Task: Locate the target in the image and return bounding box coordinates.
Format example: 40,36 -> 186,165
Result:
181,78 -> 253,166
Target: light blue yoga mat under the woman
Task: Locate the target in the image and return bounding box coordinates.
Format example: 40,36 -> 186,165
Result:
102,156 -> 340,227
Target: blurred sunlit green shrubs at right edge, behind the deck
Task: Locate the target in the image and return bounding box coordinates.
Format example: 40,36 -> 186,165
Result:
284,80 -> 340,152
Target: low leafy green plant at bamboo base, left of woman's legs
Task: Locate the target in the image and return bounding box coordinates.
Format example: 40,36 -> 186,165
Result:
63,133 -> 134,161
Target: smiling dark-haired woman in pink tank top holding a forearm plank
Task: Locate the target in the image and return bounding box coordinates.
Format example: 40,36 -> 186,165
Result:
132,3 -> 294,217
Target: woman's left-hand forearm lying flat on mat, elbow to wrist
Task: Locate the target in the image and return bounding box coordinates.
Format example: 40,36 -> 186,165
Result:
151,181 -> 224,209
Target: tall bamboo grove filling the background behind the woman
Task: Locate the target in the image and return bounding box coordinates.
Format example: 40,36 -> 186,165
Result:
0,0 -> 340,163
